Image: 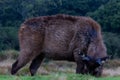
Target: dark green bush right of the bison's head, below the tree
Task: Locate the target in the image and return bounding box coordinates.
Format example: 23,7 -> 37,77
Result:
104,32 -> 120,58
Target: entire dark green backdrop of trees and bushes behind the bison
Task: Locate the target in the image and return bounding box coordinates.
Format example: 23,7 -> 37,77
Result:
0,0 -> 120,57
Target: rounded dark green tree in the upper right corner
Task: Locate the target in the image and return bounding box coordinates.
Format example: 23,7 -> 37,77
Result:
88,0 -> 120,33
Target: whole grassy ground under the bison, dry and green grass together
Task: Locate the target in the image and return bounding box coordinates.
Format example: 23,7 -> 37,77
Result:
0,50 -> 120,80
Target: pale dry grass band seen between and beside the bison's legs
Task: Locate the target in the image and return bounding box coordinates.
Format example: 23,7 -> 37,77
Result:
0,60 -> 120,76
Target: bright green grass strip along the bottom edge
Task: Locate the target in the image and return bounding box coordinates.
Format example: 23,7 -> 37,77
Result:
0,73 -> 120,80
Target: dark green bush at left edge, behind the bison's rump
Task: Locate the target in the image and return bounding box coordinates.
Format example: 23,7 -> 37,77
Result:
0,27 -> 19,51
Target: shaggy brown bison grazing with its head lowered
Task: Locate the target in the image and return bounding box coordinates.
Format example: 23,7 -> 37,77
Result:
11,14 -> 108,76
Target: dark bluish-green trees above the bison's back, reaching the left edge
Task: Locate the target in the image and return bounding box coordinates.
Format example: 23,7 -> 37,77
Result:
0,0 -> 109,27
